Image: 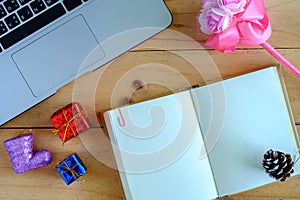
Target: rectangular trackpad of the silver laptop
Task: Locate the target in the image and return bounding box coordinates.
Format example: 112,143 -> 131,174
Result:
12,15 -> 104,96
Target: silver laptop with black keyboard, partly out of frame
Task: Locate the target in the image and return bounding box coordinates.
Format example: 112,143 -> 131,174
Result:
0,0 -> 171,125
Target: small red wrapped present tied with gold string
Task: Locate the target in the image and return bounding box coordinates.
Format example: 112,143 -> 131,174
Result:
50,102 -> 90,143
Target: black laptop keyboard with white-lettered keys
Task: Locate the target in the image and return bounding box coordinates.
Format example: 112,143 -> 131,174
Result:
0,0 -> 88,52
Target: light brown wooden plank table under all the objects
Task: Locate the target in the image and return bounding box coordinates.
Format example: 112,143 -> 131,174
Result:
0,0 -> 300,200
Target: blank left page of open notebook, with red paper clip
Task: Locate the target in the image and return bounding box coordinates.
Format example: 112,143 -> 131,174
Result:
105,91 -> 217,200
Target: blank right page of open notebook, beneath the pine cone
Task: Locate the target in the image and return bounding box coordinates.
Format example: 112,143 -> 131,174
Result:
192,67 -> 299,196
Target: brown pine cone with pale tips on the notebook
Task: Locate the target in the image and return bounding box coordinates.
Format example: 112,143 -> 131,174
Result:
262,150 -> 294,181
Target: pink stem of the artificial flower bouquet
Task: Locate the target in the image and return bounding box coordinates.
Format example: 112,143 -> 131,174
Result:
261,42 -> 300,79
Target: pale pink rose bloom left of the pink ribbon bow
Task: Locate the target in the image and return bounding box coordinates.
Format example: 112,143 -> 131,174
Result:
198,6 -> 232,35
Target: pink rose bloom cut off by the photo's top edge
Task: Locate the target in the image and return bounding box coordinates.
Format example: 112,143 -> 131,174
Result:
216,0 -> 247,15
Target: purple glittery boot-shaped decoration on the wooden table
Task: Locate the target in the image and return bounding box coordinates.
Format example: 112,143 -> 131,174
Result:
4,133 -> 51,174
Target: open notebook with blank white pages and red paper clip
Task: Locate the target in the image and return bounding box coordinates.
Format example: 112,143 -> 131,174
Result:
104,67 -> 300,200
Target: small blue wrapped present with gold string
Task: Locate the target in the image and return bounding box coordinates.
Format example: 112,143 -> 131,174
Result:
56,153 -> 86,185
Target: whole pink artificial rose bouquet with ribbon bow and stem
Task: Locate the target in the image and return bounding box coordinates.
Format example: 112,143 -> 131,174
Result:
198,0 -> 300,79
